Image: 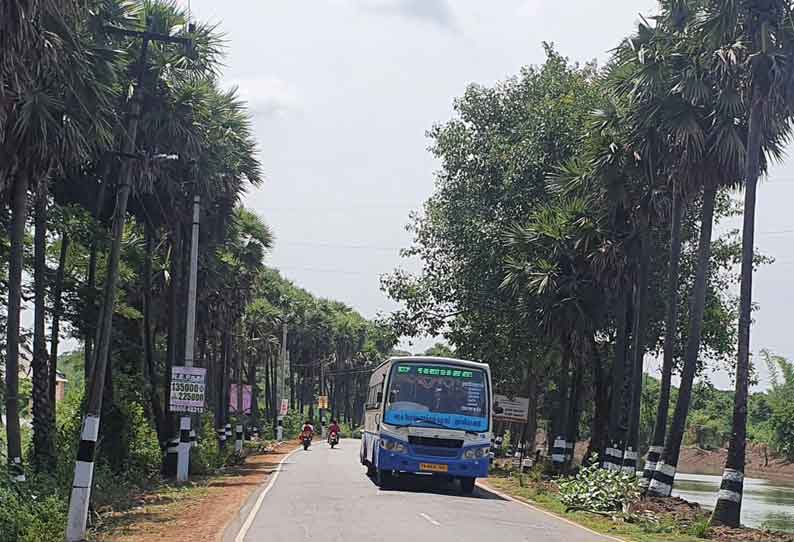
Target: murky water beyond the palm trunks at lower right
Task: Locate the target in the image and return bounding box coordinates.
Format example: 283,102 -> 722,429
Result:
673,474 -> 794,532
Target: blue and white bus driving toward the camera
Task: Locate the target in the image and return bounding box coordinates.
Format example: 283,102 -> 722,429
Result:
360,357 -> 492,493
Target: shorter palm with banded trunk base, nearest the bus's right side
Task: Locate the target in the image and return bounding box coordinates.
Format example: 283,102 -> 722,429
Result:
503,196 -> 604,468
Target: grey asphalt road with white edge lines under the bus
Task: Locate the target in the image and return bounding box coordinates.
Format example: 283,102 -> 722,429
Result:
238,440 -> 609,542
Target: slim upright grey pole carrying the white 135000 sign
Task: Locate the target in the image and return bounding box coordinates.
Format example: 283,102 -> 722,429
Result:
176,193 -> 201,482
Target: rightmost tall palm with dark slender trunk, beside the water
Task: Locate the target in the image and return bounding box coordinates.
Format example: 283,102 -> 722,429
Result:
704,0 -> 794,527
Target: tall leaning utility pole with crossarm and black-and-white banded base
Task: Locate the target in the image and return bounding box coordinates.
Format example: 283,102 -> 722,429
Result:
66,20 -> 190,542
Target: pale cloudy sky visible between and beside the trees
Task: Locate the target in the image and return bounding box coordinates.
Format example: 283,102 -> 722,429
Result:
156,0 -> 794,388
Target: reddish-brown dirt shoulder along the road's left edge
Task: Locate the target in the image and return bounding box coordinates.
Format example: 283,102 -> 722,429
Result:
96,442 -> 296,542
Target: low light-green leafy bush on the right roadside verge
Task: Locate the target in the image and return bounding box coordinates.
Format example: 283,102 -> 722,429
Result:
560,463 -> 640,512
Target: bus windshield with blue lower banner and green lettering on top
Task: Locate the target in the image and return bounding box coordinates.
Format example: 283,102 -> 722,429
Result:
383,363 -> 488,432
